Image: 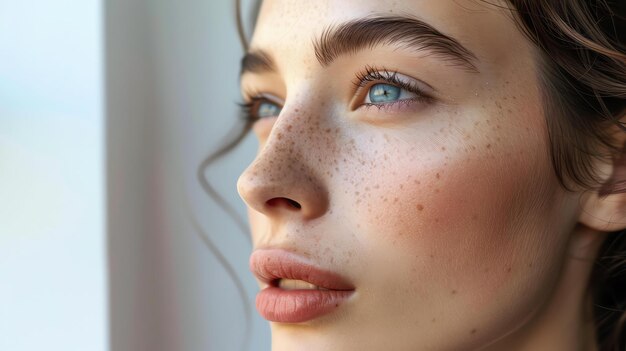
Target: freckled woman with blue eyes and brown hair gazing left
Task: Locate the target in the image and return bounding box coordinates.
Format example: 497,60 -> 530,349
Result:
212,0 -> 626,351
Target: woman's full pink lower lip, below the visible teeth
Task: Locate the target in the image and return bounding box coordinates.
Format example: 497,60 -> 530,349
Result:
256,286 -> 354,323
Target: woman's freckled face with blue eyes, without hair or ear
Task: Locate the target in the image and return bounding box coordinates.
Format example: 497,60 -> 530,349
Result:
238,0 -> 578,350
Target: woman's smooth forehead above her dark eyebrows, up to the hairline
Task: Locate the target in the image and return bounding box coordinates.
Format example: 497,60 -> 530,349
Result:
251,0 -> 533,77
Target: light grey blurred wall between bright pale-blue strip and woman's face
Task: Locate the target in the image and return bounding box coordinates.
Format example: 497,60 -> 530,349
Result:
105,0 -> 270,351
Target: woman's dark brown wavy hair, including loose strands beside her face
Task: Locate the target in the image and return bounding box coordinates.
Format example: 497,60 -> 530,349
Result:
198,0 -> 626,351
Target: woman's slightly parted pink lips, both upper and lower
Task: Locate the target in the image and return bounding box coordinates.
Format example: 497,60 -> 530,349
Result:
250,249 -> 354,323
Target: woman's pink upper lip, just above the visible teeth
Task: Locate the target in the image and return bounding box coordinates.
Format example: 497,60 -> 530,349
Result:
250,249 -> 354,290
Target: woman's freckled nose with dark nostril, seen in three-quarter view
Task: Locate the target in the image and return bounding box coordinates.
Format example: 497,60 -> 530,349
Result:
237,109 -> 329,220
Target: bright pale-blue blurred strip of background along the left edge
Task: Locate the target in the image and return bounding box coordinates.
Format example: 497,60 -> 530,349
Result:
0,0 -> 108,351
